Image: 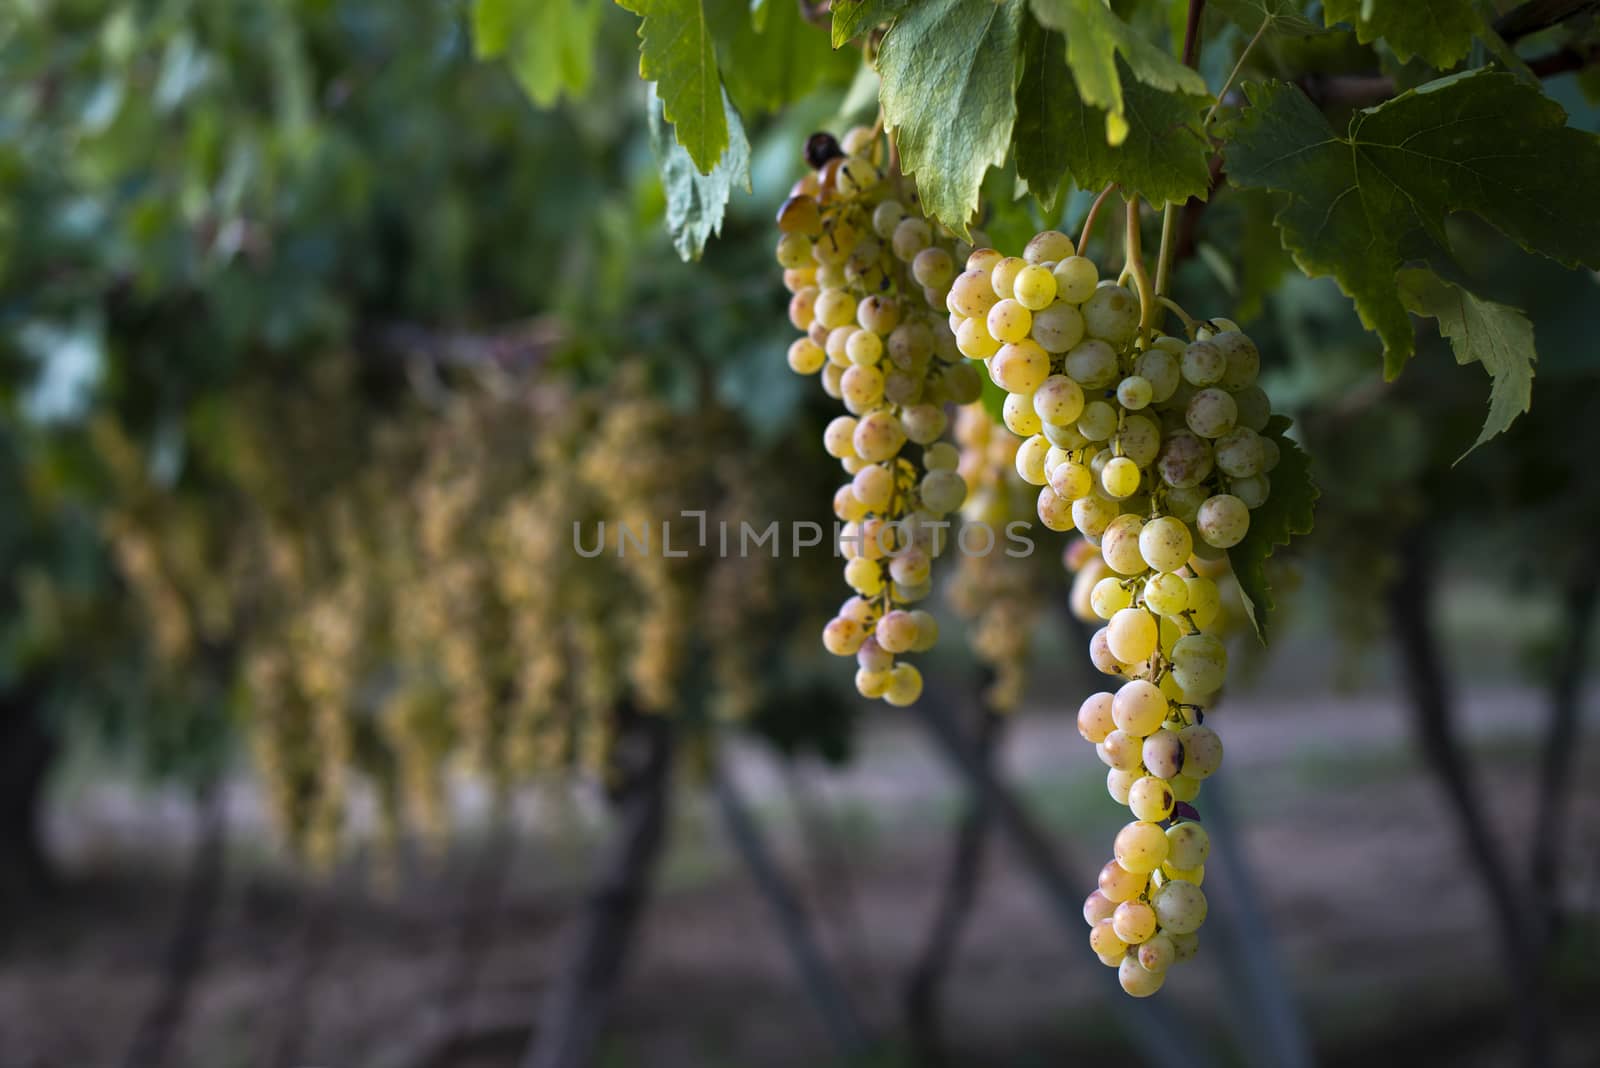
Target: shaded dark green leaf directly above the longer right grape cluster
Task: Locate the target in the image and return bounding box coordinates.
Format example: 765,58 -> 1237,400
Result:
1043,55 -> 1211,205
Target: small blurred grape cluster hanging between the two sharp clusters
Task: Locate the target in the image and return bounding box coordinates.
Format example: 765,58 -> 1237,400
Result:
947,404 -> 1046,711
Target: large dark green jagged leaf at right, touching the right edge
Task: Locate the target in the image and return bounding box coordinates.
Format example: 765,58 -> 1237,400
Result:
1224,72 -> 1600,379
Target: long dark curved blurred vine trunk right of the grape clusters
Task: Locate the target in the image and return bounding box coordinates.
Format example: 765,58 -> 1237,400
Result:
1389,529 -> 1549,1068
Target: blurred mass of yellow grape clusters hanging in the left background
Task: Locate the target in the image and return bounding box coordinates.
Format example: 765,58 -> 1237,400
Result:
107,365 -> 793,863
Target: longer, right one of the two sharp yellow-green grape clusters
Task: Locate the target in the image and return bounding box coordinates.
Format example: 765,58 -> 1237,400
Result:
947,230 -> 1278,998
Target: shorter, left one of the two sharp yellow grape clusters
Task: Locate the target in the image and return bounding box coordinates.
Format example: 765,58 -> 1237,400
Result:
778,128 -> 982,705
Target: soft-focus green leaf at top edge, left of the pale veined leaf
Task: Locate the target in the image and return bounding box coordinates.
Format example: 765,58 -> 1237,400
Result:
702,0 -> 856,115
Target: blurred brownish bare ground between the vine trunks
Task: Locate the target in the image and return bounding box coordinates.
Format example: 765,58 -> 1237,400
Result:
0,687 -> 1600,1068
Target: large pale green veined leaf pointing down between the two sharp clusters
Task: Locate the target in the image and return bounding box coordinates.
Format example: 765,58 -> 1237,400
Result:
878,0 -> 1024,237
